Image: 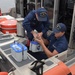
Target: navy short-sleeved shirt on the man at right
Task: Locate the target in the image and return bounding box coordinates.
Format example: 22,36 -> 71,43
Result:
48,33 -> 68,53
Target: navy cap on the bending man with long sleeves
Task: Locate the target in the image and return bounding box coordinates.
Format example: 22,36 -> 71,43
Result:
36,8 -> 47,21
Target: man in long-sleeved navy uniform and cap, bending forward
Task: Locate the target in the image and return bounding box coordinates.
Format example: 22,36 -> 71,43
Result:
23,8 -> 50,40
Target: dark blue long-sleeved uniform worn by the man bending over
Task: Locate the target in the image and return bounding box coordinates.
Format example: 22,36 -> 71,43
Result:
23,10 -> 50,40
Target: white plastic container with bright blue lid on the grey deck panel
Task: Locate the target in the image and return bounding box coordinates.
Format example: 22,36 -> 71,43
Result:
10,42 -> 27,62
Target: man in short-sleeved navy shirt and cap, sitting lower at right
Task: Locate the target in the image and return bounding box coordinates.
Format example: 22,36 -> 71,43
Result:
35,23 -> 68,58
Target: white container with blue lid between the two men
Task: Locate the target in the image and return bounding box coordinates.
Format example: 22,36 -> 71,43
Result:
29,41 -> 43,52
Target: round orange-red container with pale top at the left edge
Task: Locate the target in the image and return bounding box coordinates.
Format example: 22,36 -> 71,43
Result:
0,20 -> 17,34
